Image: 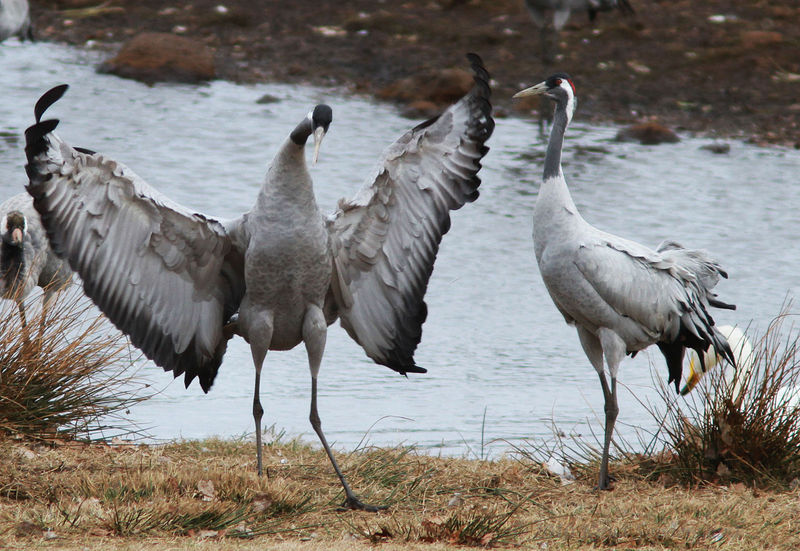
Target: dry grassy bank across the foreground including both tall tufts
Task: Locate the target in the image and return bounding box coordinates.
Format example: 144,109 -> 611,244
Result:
0,294 -> 800,551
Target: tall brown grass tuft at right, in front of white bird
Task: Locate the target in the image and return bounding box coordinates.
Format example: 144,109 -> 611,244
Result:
642,306 -> 800,489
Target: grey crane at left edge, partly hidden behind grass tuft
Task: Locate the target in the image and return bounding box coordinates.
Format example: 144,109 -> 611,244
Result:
0,193 -> 72,329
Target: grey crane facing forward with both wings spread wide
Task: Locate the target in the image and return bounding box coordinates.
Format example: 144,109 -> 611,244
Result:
25,54 -> 494,511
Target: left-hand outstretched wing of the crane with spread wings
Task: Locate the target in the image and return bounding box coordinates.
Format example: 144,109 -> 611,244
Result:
25,85 -> 244,391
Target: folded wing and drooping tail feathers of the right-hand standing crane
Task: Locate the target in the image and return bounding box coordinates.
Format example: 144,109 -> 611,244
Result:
575,234 -> 735,390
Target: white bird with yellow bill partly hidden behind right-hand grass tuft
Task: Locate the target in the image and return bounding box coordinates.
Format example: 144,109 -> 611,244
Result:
681,325 -> 800,410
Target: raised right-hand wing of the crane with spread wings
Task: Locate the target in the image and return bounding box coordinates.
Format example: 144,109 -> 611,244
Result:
329,54 -> 494,374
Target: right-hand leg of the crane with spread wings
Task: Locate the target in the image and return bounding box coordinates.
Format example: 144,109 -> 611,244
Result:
303,306 -> 385,512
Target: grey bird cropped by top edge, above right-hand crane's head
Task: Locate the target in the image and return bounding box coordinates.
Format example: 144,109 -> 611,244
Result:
525,0 -> 635,63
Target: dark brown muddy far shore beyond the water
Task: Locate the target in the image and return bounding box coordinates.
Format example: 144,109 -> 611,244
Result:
26,0 -> 800,148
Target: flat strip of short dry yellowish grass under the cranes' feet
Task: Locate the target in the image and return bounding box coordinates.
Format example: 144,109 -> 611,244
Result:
0,440 -> 800,550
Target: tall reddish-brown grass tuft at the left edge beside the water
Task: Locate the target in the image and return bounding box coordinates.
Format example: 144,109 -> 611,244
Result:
0,291 -> 145,439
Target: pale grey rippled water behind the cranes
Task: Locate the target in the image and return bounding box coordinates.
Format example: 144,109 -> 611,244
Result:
0,41 -> 800,455
